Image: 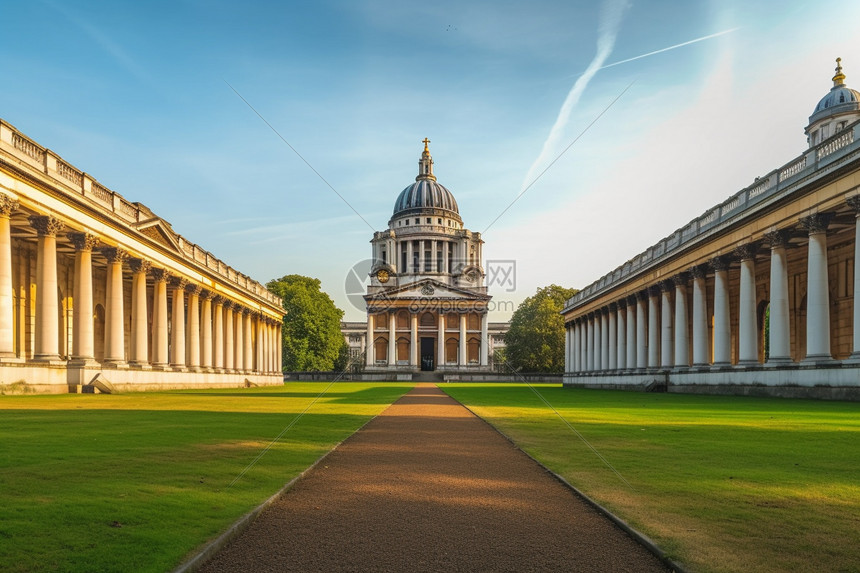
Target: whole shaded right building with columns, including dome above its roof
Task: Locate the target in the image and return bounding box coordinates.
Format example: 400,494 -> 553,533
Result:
563,61 -> 860,394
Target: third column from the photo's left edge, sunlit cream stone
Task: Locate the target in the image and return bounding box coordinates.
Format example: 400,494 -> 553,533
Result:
68,231 -> 99,365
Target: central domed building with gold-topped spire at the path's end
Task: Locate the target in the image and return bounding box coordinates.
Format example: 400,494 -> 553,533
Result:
364,138 -> 491,373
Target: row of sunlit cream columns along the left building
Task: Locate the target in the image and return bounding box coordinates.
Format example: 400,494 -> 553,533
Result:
0,199 -> 281,374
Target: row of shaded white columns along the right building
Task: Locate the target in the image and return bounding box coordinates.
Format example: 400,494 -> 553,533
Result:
565,206 -> 860,373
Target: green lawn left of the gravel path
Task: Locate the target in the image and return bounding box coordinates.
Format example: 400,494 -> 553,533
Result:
0,383 -> 411,573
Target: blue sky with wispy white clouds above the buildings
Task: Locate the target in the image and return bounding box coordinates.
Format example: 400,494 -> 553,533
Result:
0,0 -> 860,320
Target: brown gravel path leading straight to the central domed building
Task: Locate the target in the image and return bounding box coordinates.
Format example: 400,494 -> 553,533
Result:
201,385 -> 667,573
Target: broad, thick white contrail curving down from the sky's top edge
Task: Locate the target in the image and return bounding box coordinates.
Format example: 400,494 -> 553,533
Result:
522,0 -> 627,190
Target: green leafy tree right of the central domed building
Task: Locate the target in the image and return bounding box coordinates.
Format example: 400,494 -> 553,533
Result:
505,285 -> 578,372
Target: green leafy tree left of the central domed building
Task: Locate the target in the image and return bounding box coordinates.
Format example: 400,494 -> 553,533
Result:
266,275 -> 346,371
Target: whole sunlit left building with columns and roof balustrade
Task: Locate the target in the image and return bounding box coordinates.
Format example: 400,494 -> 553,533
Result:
0,120 -> 283,392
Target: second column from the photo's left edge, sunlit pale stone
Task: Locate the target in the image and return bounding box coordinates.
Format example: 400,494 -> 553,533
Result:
30,215 -> 64,362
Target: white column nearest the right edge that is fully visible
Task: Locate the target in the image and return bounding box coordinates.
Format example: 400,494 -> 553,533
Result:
800,213 -> 833,362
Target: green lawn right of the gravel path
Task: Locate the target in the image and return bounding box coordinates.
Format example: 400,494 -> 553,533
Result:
442,384 -> 860,573
